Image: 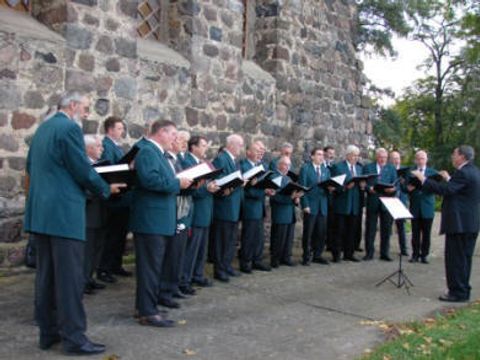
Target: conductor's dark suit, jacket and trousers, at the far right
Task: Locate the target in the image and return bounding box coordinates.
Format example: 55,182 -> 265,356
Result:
423,163 -> 480,300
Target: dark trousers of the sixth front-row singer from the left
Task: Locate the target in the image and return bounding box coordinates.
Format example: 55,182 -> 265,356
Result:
239,219 -> 265,268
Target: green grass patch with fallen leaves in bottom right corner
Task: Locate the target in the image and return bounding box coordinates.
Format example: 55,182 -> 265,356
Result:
362,302 -> 480,360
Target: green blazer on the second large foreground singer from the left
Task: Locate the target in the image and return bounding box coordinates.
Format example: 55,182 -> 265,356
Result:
130,141 -> 180,236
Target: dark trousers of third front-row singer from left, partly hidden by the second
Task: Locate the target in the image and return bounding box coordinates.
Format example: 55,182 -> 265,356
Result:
158,229 -> 188,299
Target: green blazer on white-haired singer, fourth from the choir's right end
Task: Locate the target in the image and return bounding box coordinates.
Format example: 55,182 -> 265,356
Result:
331,161 -> 362,215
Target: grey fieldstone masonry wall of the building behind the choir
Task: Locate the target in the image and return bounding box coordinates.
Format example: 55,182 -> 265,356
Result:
0,0 -> 370,267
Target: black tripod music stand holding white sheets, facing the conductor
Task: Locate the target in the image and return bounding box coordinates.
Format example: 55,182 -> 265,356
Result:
375,197 -> 414,295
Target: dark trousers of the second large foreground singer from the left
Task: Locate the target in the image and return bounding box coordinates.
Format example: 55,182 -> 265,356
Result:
134,233 -> 167,316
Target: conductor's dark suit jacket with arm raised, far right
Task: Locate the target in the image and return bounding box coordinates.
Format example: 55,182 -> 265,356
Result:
423,163 -> 480,234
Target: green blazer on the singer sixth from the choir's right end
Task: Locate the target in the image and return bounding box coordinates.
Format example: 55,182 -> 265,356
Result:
298,161 -> 330,216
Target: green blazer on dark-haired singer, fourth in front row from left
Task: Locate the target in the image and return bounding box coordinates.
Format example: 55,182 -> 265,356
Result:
184,152 -> 213,227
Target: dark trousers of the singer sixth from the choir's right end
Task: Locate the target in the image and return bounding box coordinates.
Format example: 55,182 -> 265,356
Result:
302,212 -> 327,261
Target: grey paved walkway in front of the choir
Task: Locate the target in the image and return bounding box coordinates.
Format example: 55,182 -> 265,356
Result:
0,218 -> 480,360
